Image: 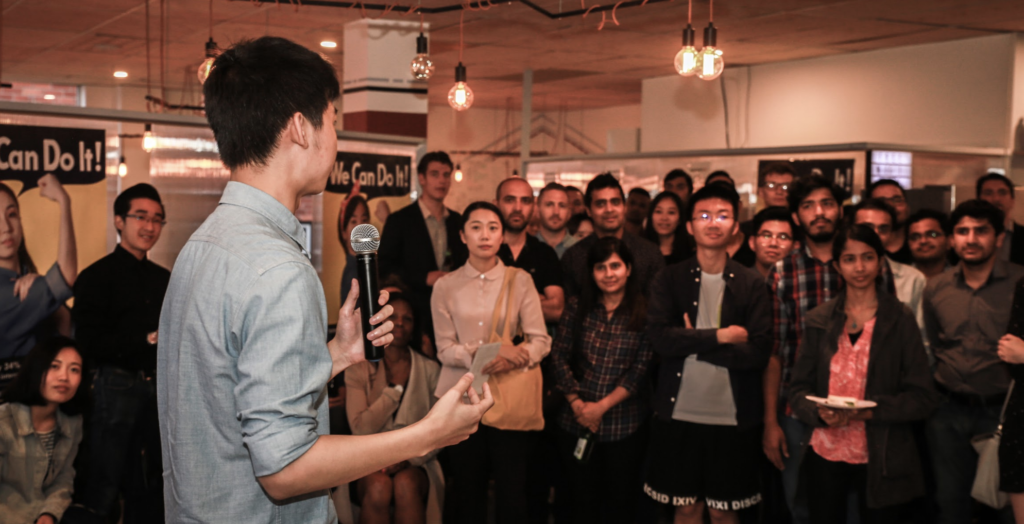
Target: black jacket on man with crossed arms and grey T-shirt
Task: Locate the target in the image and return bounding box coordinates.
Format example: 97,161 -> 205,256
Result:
647,257 -> 772,429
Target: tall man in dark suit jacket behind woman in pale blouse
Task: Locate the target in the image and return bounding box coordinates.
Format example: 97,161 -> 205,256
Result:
377,151 -> 469,339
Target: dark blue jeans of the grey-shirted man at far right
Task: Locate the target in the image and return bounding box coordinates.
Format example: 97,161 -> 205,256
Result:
925,400 -> 1013,524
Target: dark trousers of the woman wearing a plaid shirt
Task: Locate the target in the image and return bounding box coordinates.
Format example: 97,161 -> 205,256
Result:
558,428 -> 647,524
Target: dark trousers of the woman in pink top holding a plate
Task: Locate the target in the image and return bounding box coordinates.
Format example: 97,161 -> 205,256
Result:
802,446 -> 899,524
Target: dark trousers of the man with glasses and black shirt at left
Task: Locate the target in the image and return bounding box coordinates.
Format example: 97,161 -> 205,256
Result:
80,366 -> 164,524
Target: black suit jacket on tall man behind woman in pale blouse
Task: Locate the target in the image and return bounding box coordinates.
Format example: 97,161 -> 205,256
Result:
377,202 -> 469,330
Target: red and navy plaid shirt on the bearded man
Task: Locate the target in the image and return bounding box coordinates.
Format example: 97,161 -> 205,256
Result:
768,248 -> 896,414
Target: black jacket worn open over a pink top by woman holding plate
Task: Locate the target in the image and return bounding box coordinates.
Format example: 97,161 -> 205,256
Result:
790,292 -> 941,508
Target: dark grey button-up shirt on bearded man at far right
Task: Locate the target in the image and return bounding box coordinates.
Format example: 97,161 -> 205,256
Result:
924,260 -> 1024,396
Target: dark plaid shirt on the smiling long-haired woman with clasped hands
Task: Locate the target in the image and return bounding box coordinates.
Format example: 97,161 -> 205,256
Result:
551,297 -> 653,442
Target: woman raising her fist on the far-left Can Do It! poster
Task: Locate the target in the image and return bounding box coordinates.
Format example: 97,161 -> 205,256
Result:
0,175 -> 78,370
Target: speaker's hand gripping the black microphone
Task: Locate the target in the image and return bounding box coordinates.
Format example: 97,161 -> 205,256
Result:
328,278 -> 394,377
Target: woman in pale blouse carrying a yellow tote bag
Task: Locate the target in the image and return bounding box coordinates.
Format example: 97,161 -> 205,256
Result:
430,202 -> 551,524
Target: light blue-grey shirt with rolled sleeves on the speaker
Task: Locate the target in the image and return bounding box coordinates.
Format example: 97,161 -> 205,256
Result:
157,181 -> 337,523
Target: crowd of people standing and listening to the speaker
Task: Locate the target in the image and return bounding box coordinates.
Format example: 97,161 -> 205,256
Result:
0,146 -> 1024,524
